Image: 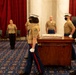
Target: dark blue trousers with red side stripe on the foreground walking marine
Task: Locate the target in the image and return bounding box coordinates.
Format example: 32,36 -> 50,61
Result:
24,44 -> 44,74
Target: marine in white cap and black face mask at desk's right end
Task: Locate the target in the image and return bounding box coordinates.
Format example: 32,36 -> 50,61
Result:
64,14 -> 75,37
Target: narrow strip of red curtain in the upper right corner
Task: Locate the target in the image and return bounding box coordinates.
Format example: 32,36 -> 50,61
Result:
69,0 -> 76,16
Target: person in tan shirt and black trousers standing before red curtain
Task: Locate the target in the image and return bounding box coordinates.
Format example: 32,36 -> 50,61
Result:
7,20 -> 17,49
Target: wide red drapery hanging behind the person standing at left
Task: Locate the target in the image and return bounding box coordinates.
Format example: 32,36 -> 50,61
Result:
0,0 -> 27,36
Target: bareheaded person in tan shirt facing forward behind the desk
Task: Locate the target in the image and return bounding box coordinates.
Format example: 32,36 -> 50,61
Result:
45,16 -> 57,34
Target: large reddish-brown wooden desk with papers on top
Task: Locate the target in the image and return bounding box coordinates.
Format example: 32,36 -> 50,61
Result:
38,37 -> 74,66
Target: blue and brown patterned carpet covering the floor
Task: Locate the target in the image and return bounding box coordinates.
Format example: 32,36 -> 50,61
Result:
0,41 -> 76,75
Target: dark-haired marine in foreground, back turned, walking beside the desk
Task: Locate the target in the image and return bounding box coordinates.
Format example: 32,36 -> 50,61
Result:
19,16 -> 44,75
